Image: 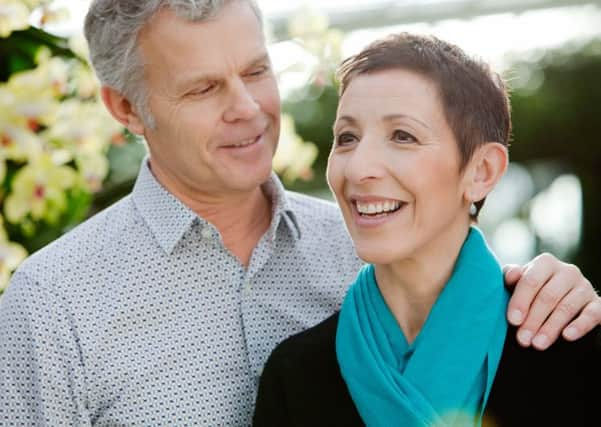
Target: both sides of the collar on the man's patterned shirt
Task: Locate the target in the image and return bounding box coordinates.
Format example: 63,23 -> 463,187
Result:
132,157 -> 300,254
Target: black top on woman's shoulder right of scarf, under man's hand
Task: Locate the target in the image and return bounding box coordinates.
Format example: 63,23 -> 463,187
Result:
487,327 -> 601,426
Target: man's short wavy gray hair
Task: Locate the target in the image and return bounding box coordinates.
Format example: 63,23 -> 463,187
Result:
84,0 -> 262,128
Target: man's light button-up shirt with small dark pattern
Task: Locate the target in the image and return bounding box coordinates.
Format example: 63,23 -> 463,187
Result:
0,162 -> 360,427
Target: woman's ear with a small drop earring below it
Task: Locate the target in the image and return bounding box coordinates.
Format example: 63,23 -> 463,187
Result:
464,142 -> 509,203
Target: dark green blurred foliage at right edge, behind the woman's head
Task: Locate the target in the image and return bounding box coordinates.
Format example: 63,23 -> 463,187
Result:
511,40 -> 601,289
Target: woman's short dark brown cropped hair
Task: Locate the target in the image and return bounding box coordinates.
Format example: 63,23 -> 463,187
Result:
337,33 -> 511,216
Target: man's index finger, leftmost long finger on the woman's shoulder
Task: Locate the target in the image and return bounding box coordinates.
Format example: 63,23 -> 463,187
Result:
507,255 -> 557,330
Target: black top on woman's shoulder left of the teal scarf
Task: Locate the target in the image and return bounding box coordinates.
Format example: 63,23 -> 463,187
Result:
254,314 -> 363,427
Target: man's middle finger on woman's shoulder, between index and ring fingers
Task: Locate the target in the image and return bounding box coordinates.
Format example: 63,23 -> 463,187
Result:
518,264 -> 581,346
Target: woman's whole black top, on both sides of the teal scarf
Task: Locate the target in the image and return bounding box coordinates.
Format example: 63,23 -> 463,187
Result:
253,314 -> 601,427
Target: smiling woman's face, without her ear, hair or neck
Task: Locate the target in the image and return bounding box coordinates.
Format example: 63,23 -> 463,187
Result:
327,69 -> 469,264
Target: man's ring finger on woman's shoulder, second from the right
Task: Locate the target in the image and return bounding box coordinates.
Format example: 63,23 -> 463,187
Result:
532,280 -> 596,350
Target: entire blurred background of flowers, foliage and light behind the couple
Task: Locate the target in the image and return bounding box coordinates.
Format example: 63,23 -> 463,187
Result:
0,0 -> 601,293
